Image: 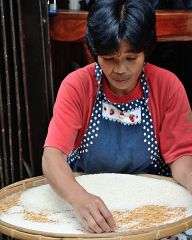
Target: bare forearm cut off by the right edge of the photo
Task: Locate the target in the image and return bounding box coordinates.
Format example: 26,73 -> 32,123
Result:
170,156 -> 192,192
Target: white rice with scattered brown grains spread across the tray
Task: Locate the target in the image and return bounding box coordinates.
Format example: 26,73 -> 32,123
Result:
0,173 -> 192,234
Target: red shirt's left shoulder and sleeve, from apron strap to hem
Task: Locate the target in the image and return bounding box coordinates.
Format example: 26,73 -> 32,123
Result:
44,63 -> 98,155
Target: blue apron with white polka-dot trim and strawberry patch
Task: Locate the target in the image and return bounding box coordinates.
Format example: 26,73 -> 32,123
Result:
68,64 -> 170,176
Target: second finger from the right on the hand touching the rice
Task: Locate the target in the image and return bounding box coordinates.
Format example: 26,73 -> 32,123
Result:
91,209 -> 111,232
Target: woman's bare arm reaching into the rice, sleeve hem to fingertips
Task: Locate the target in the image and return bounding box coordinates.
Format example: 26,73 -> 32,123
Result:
42,147 -> 115,233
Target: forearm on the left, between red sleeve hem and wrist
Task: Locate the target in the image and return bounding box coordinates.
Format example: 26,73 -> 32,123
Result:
42,147 -> 85,204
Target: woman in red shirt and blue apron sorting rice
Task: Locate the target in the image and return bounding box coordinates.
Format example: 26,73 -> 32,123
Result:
42,0 -> 192,236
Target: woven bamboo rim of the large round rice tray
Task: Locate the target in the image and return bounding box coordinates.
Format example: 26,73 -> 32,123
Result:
0,174 -> 192,240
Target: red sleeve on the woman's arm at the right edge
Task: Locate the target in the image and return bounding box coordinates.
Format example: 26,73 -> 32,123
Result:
159,77 -> 192,163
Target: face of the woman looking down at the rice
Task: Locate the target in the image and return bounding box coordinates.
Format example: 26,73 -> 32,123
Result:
98,42 -> 145,95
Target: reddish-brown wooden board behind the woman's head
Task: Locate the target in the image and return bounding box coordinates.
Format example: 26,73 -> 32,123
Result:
50,10 -> 192,42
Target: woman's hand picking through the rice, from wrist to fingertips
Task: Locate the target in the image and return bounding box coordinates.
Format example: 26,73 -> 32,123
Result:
71,191 -> 116,233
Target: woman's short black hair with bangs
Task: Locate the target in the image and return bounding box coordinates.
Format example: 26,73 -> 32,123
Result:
86,0 -> 156,57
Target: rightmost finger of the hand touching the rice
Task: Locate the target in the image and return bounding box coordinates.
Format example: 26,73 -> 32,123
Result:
99,203 -> 117,232
